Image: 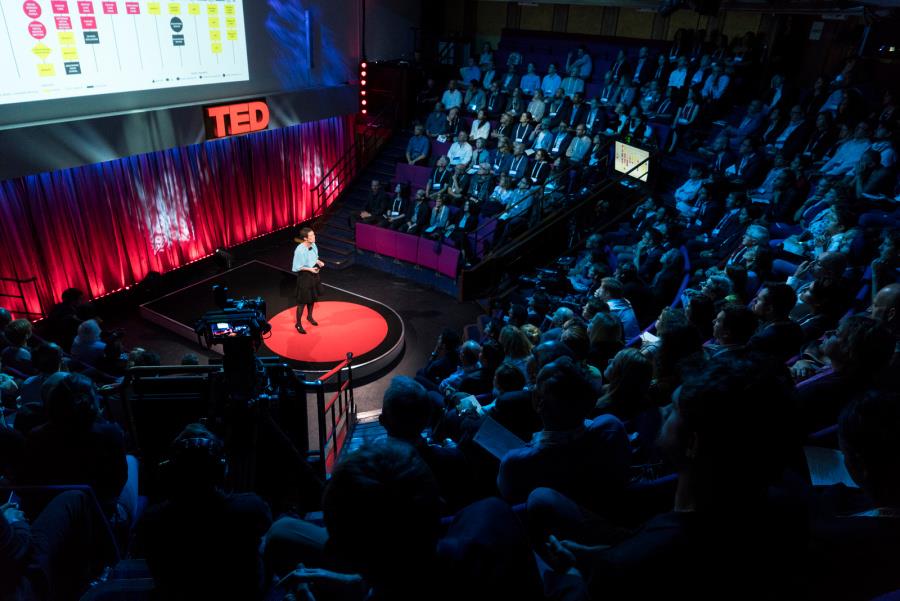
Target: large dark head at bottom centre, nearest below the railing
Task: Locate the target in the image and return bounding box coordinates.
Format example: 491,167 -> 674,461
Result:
322,438 -> 441,599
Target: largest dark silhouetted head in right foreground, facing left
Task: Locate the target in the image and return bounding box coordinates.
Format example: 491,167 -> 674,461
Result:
658,357 -> 790,515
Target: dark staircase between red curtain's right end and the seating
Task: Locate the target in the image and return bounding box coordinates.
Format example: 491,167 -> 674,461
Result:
316,132 -> 410,270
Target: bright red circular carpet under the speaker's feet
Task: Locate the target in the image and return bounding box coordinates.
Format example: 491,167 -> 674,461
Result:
263,301 -> 388,363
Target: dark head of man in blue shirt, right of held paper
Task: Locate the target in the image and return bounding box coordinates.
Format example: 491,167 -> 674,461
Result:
533,357 -> 595,432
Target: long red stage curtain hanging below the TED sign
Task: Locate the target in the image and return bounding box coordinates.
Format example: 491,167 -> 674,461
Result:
0,116 -> 353,312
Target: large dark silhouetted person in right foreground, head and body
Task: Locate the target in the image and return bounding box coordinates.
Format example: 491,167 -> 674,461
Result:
547,360 -> 801,599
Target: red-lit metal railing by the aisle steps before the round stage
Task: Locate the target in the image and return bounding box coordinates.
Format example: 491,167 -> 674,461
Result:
304,353 -> 356,479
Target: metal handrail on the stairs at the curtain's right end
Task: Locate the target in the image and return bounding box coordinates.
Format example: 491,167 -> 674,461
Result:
312,106 -> 396,217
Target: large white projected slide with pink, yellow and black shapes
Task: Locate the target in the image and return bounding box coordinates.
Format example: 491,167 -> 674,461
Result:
0,0 -> 250,105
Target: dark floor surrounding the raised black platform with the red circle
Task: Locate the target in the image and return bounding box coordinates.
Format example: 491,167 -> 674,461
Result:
100,232 -> 480,412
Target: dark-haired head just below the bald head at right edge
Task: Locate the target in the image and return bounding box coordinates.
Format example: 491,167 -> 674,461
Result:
822,315 -> 896,381
